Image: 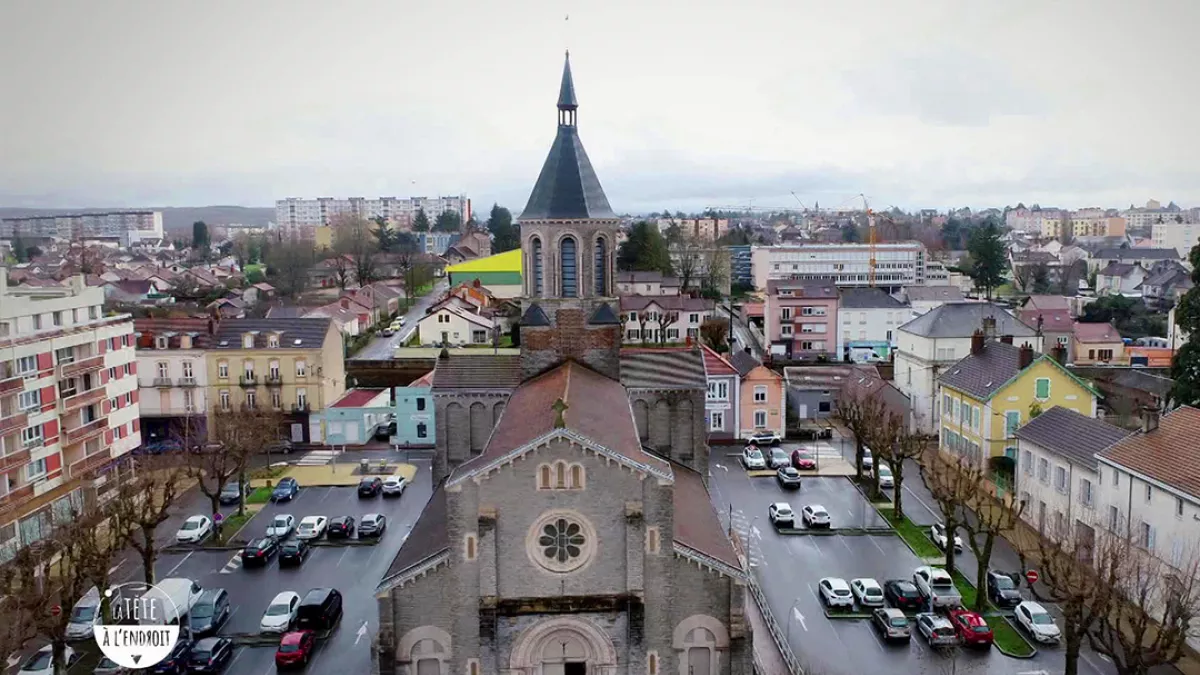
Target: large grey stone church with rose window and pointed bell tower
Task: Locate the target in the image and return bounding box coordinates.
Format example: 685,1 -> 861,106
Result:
373,56 -> 752,675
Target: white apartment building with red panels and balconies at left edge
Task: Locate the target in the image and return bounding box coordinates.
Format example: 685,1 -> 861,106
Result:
0,273 -> 142,562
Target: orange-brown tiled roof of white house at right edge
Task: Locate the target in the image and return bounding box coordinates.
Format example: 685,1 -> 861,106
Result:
1098,406 -> 1200,497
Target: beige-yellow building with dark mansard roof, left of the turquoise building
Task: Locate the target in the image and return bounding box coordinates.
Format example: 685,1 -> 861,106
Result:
205,318 -> 346,442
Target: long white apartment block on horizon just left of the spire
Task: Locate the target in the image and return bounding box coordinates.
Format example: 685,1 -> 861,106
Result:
275,195 -> 470,229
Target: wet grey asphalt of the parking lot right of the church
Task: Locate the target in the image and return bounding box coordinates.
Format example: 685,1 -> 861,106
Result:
710,444 -> 1114,675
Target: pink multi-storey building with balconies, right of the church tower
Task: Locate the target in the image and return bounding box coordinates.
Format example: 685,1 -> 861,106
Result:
763,280 -> 838,360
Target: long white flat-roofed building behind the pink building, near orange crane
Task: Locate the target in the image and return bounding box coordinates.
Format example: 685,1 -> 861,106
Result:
750,241 -> 928,293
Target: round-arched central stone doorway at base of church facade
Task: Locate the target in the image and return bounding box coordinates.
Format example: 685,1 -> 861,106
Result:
509,616 -> 617,675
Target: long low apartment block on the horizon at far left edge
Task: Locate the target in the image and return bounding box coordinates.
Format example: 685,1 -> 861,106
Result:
0,211 -> 163,246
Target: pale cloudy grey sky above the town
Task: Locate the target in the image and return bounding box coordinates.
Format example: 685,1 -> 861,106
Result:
0,0 -> 1200,211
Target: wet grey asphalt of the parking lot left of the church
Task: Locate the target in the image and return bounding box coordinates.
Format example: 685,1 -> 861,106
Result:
96,461 -> 432,675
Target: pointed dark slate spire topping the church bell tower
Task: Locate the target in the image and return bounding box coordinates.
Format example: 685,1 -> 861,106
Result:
520,53 -> 617,220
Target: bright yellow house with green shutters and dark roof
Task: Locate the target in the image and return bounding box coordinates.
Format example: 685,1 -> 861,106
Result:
938,334 -> 1098,465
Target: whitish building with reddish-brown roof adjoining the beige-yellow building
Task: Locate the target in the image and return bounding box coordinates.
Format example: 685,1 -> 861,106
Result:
133,318 -> 215,447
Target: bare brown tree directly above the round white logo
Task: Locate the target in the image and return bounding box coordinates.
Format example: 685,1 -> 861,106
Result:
112,453 -> 188,584
